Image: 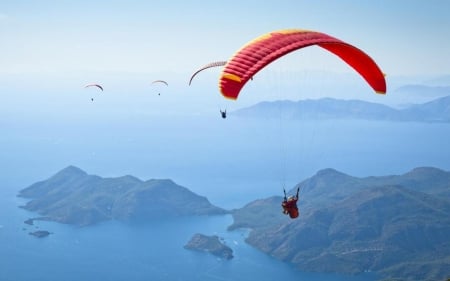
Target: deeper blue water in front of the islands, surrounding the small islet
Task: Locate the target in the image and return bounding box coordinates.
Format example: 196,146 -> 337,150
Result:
0,187 -> 375,281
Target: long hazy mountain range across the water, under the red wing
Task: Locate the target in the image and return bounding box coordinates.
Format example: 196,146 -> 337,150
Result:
231,96 -> 450,122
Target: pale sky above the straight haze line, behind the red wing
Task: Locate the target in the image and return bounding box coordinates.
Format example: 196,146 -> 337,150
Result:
0,0 -> 450,75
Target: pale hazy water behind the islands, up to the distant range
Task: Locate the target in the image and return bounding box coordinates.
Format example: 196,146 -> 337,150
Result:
0,114 -> 450,208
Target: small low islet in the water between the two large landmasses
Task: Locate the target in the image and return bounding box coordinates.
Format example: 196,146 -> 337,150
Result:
184,233 -> 233,260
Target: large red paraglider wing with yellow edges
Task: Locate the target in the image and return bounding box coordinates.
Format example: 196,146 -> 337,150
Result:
219,29 -> 386,100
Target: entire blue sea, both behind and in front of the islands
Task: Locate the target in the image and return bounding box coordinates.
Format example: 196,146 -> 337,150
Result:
0,112 -> 450,281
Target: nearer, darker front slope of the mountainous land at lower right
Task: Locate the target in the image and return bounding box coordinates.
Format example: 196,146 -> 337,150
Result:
247,186 -> 450,277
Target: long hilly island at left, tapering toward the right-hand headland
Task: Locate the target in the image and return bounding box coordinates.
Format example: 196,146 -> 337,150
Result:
19,166 -> 226,226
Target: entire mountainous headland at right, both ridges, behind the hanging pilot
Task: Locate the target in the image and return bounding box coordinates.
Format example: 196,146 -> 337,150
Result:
230,168 -> 450,280
